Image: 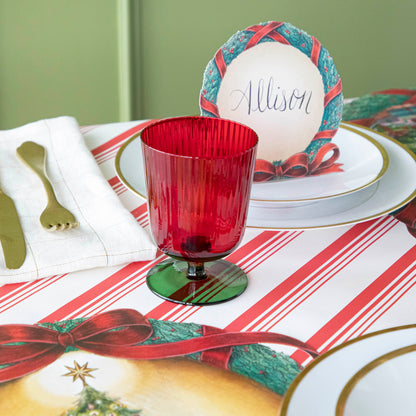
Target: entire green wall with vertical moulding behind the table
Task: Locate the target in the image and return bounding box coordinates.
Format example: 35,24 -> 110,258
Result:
0,0 -> 416,129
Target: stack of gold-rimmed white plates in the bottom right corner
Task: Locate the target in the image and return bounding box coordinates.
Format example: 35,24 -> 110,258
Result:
280,325 -> 416,416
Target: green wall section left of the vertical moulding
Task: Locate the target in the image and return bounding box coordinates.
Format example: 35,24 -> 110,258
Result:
0,0 -> 120,129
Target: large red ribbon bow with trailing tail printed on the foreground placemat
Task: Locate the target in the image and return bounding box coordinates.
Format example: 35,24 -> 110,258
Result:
0,309 -> 318,382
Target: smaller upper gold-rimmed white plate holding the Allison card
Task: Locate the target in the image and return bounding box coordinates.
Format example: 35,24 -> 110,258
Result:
250,124 -> 388,208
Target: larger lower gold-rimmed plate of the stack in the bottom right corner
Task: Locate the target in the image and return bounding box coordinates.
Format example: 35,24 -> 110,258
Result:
280,325 -> 416,416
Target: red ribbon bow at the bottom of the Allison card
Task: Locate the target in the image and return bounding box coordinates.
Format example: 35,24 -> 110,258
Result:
254,143 -> 342,182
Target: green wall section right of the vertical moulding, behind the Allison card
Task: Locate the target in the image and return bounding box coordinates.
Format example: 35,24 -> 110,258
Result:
141,0 -> 416,117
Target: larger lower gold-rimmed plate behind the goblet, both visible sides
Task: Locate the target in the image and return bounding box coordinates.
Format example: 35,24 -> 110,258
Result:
115,124 -> 416,229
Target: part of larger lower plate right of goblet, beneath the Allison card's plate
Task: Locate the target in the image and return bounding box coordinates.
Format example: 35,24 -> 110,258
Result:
247,124 -> 416,229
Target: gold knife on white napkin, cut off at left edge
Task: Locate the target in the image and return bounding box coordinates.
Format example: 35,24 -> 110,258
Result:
0,185 -> 26,269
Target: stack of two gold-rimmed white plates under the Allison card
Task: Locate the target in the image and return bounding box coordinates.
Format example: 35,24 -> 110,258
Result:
115,123 -> 416,229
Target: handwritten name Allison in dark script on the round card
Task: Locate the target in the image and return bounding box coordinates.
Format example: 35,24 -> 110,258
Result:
231,77 -> 312,114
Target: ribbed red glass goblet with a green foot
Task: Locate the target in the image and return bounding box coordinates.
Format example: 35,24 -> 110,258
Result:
141,116 -> 258,305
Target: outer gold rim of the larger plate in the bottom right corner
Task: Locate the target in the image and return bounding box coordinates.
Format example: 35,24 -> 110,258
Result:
279,324 -> 416,416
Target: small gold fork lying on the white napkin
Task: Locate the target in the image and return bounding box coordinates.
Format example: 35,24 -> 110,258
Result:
16,142 -> 79,231
